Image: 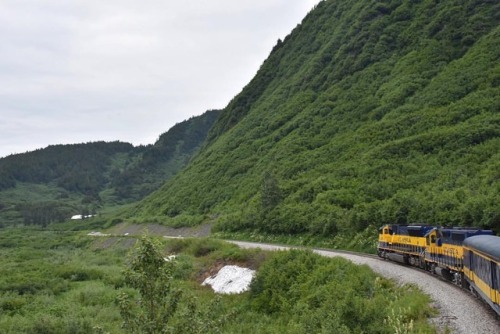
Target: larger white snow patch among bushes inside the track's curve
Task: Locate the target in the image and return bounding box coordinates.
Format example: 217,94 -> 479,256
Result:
201,266 -> 255,294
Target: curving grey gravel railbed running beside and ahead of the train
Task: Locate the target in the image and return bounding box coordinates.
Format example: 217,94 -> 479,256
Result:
230,241 -> 500,334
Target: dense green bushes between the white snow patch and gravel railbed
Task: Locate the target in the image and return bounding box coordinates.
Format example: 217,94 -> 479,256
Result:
250,250 -> 432,334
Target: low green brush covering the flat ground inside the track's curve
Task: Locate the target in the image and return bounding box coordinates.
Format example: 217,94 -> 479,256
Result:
0,228 -> 434,334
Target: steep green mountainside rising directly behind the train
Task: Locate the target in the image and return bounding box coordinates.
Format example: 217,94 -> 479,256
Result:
133,0 -> 500,240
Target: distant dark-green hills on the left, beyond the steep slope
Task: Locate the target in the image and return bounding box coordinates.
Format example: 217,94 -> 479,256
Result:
0,110 -> 219,225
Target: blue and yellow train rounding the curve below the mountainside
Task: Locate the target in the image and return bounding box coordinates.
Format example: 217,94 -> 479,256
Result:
377,224 -> 500,316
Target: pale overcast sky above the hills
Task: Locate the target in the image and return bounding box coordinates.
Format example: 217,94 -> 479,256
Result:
0,0 -> 319,157
